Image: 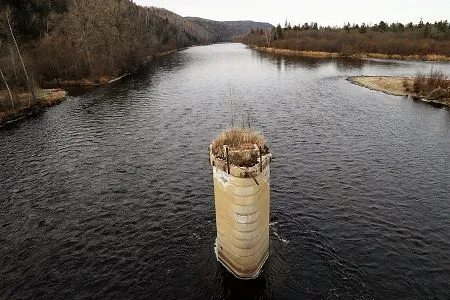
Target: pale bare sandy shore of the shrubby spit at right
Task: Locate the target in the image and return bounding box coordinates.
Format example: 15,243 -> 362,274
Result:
347,76 -> 450,107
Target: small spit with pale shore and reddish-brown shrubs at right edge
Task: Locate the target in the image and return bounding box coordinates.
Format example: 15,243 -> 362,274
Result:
347,72 -> 450,107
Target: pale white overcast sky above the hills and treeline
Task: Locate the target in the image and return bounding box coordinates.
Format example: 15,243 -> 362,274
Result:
134,0 -> 450,26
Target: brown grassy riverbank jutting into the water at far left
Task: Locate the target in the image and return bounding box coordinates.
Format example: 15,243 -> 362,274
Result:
0,89 -> 67,127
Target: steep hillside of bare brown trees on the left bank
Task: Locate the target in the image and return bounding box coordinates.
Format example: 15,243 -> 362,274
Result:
0,0 -> 221,89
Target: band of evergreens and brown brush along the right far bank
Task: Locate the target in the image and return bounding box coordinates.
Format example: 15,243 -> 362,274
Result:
243,21 -> 450,58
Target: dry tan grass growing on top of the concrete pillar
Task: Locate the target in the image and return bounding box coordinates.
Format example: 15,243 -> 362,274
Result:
211,128 -> 269,167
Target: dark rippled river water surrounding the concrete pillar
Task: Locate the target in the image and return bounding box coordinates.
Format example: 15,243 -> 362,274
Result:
0,44 -> 450,299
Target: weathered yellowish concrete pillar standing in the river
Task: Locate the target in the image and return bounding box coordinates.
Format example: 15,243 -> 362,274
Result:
210,130 -> 272,279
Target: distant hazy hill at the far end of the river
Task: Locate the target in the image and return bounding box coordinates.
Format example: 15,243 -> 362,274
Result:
185,17 -> 273,42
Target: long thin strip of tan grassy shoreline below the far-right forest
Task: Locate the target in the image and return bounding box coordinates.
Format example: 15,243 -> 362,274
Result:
247,45 -> 450,62
